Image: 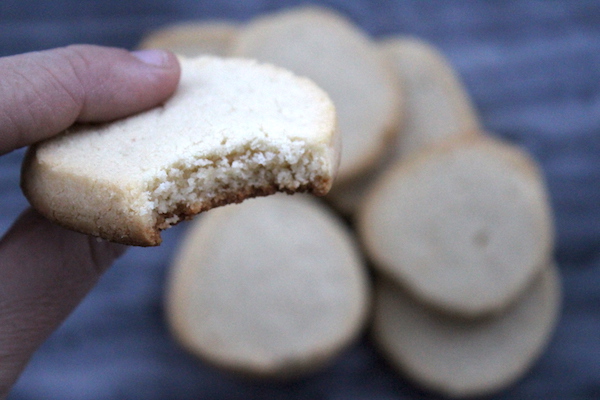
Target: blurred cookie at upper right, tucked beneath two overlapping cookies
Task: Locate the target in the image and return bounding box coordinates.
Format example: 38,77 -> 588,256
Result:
327,36 -> 481,216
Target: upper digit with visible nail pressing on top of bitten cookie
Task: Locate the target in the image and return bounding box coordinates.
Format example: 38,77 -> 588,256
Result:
0,45 -> 180,154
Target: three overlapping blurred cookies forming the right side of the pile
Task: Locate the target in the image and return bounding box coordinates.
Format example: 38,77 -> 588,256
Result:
358,38 -> 561,397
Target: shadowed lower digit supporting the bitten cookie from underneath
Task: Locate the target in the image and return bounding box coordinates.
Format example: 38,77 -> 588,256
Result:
0,209 -> 126,398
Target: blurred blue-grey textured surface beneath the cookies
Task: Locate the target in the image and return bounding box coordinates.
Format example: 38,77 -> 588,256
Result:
0,0 -> 600,400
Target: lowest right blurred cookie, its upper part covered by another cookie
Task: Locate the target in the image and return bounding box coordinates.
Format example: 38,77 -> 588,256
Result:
373,265 -> 561,398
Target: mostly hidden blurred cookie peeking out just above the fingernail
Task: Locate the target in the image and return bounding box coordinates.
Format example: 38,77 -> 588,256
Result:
138,21 -> 239,57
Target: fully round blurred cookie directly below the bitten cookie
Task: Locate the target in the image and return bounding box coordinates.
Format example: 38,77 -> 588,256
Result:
167,195 -> 370,378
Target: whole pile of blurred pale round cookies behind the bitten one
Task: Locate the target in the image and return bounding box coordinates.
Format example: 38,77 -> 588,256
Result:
142,7 -> 561,397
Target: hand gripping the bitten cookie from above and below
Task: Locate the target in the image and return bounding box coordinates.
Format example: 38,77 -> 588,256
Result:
0,46 -> 180,398
